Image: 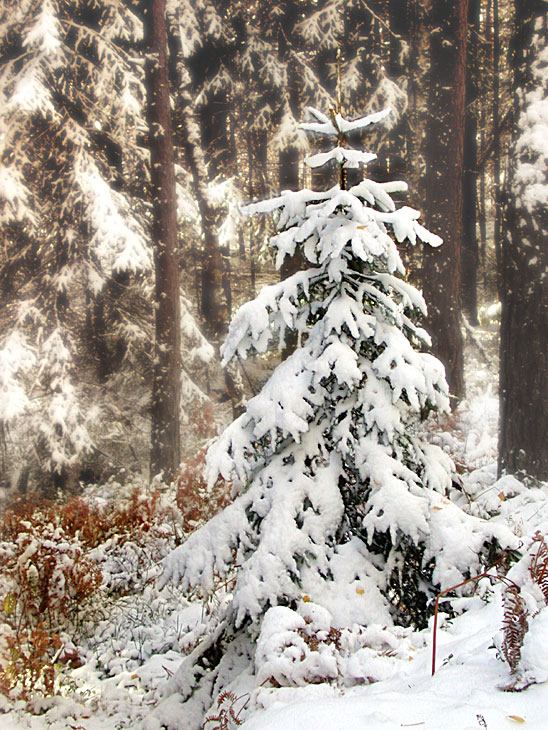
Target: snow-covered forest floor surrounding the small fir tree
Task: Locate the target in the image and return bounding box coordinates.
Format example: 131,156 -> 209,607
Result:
0,318 -> 548,730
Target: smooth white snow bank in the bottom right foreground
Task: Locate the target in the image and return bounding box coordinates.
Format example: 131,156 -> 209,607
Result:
243,601 -> 548,730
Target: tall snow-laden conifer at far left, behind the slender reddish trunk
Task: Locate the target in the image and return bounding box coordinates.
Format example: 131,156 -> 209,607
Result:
0,0 -> 213,487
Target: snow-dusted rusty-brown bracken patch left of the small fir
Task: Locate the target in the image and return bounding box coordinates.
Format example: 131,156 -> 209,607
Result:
0,489 -> 181,699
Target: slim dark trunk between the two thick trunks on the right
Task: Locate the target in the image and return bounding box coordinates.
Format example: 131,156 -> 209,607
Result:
462,0 -> 481,325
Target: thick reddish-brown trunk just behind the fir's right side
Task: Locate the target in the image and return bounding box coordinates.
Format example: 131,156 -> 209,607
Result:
423,0 -> 468,399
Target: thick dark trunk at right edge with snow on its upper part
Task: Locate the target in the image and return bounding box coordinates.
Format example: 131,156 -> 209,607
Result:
499,0 -> 548,480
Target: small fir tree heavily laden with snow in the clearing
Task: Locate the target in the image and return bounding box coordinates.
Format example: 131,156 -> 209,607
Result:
151,109 -> 512,727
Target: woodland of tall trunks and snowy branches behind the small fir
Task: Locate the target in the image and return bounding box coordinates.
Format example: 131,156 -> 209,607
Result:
0,0 -> 548,528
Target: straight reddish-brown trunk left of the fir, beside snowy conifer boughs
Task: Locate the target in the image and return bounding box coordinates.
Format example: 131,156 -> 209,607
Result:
144,0 -> 181,480
